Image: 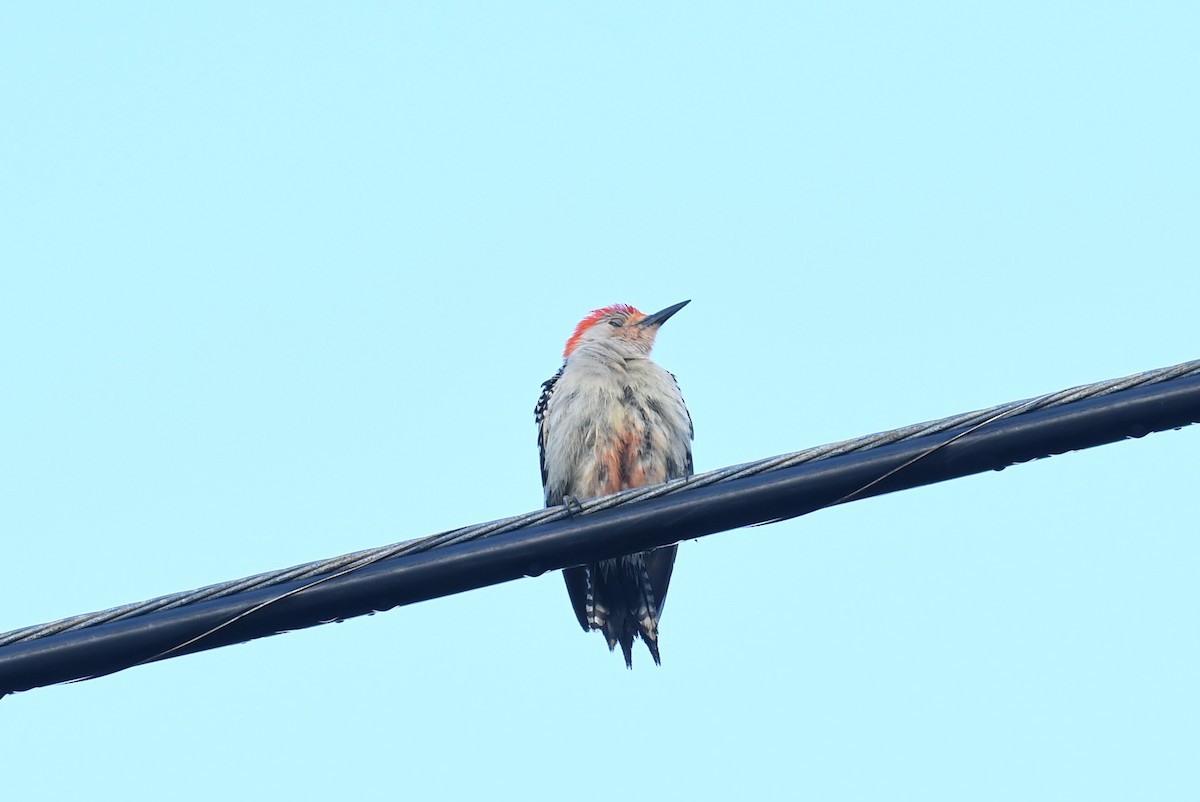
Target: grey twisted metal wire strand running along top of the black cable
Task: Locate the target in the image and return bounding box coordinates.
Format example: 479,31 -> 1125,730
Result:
0,352 -> 1200,647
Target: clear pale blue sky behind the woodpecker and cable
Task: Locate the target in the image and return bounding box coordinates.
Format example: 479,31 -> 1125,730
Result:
0,2 -> 1200,801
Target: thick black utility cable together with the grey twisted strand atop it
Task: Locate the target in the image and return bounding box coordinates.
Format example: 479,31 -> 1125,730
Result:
0,360 -> 1200,694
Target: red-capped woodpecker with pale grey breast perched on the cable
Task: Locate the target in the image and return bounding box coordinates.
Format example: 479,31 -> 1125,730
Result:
534,301 -> 692,668
